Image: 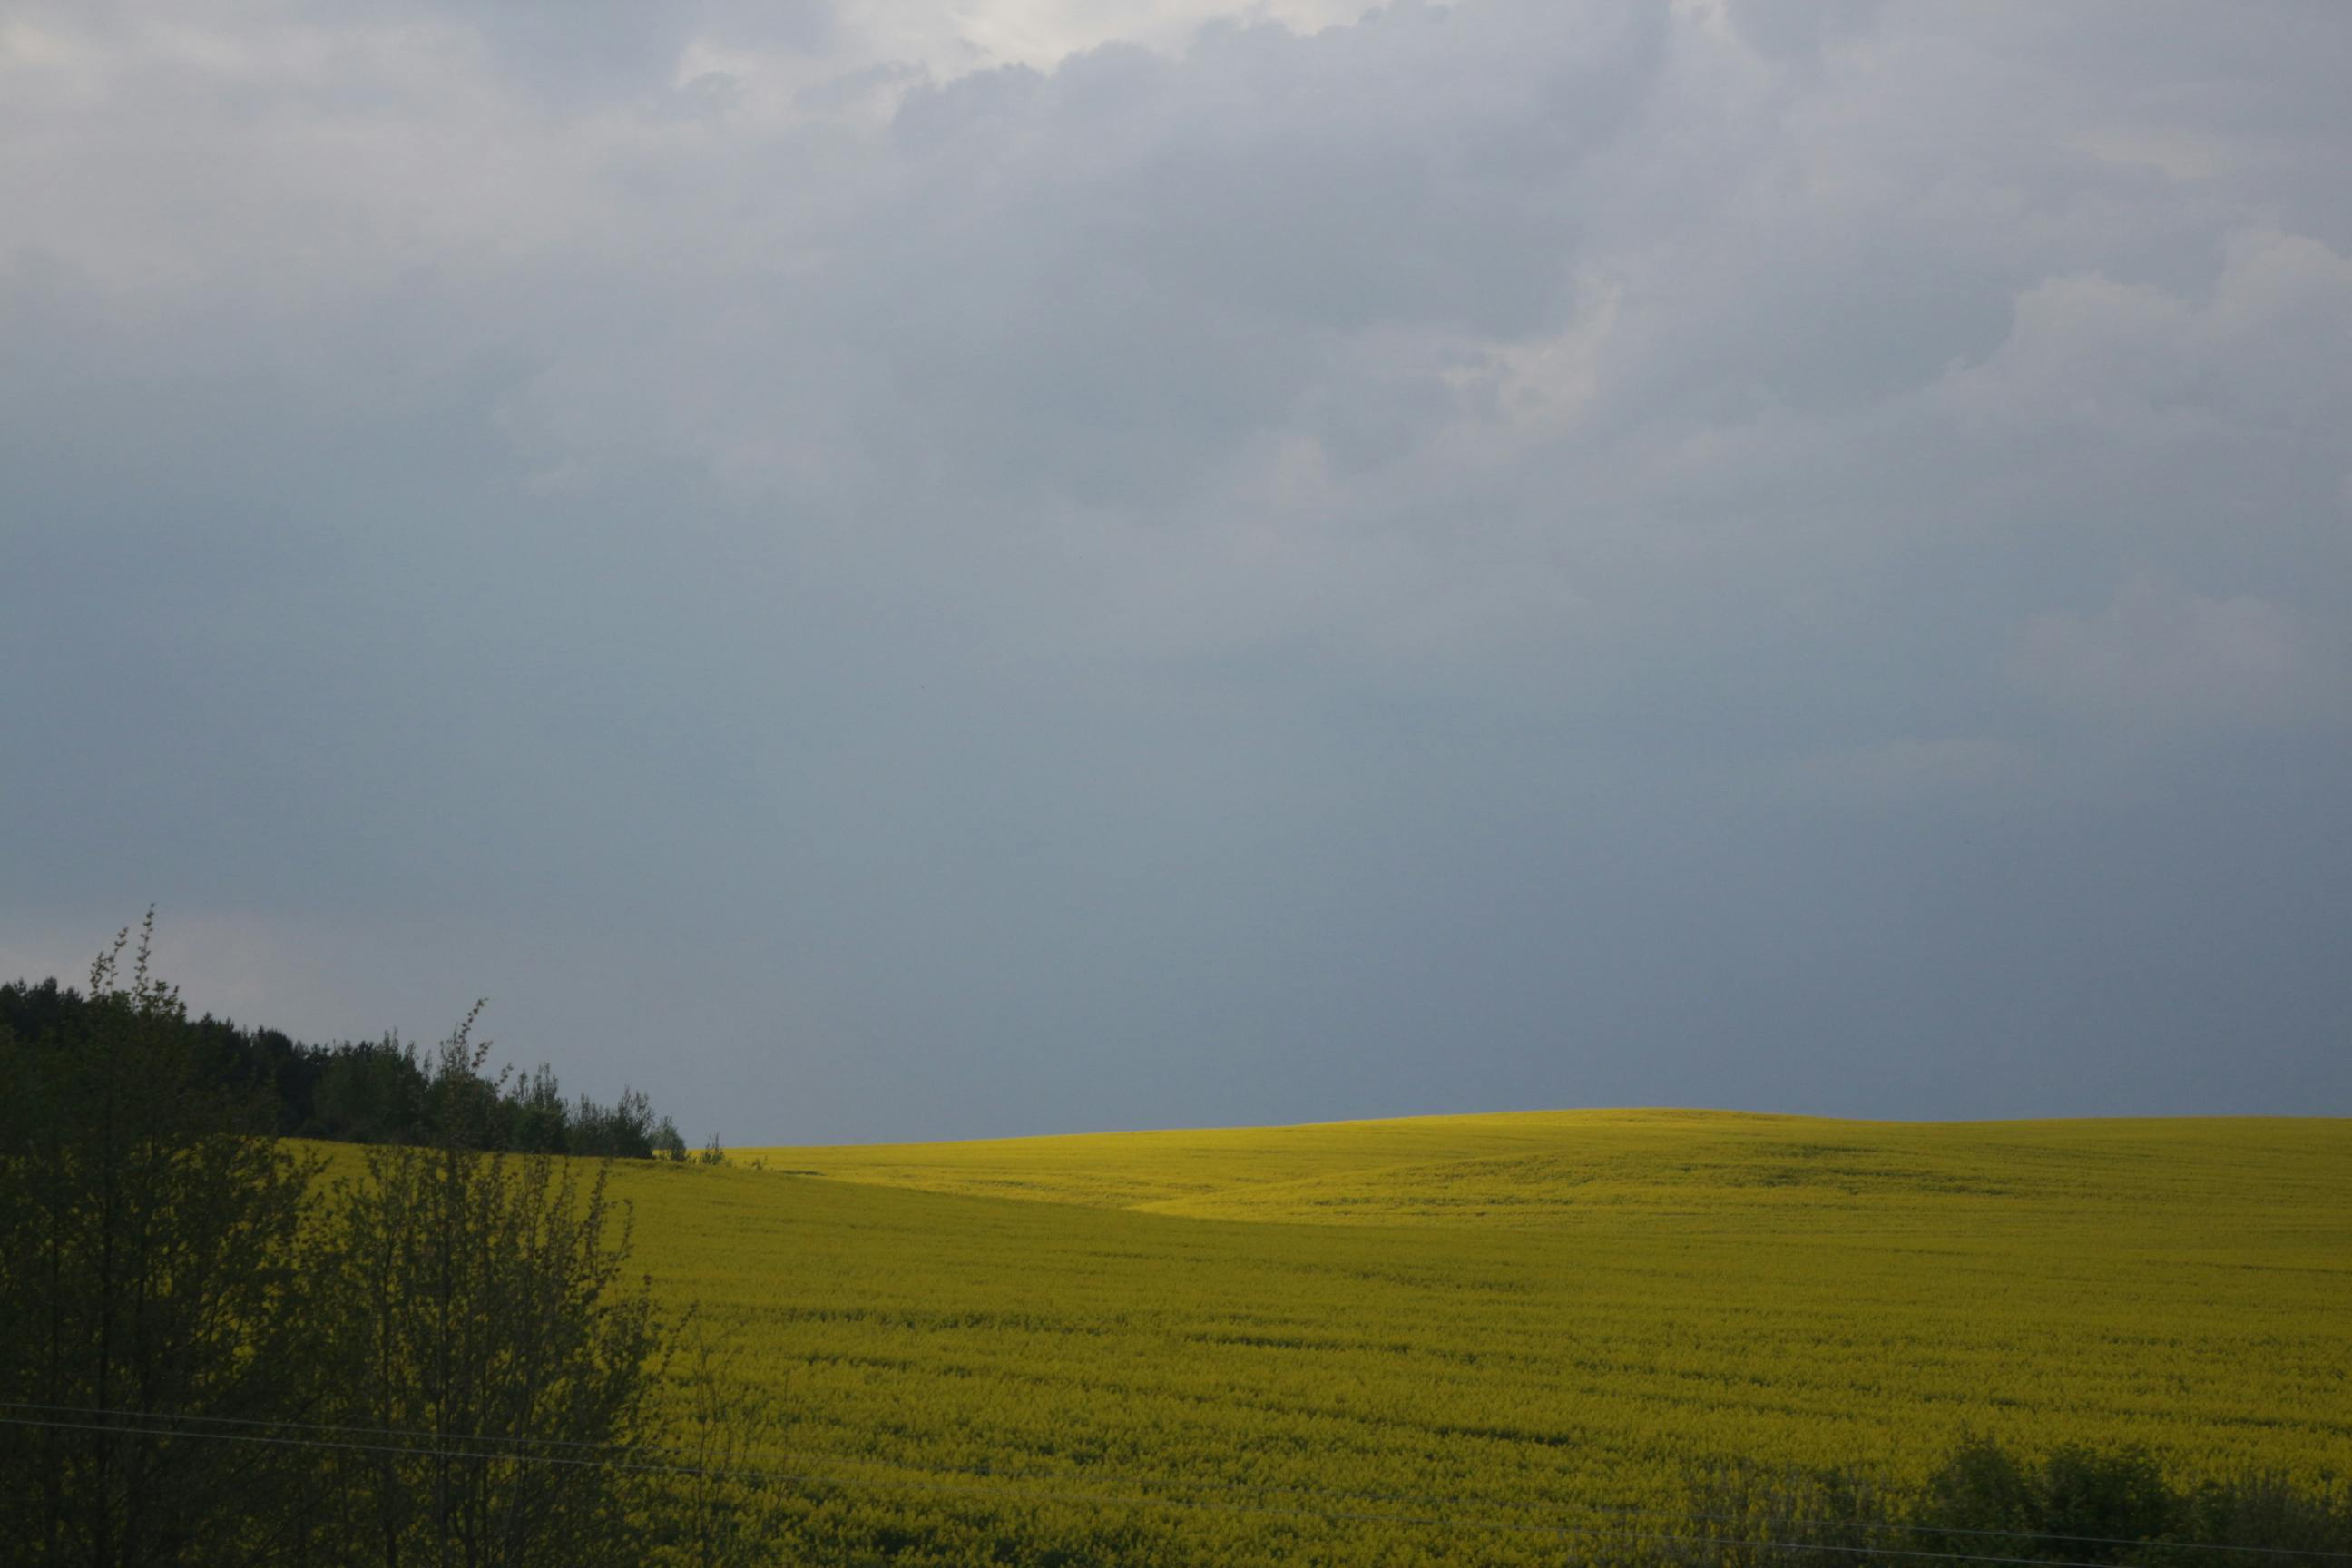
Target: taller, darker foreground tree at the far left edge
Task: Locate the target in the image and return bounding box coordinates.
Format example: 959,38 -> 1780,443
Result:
0,912 -> 313,1568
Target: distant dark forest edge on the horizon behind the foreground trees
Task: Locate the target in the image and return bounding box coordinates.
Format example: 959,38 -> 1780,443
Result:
0,978 -> 722,1163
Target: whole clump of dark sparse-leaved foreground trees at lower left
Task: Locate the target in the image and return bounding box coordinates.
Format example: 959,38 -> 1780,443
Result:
0,931 -> 752,1568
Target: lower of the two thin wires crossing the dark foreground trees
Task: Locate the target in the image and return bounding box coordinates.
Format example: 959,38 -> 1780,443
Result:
0,1416 -> 2314,1568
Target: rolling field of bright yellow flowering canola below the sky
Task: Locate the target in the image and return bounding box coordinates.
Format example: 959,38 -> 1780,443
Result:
614,1112 -> 2352,1563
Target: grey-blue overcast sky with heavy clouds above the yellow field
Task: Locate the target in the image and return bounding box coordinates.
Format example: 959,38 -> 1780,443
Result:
0,0 -> 2352,1142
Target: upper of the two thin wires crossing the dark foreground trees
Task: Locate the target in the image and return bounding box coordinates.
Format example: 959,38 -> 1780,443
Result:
0,1398 -> 2352,1561
